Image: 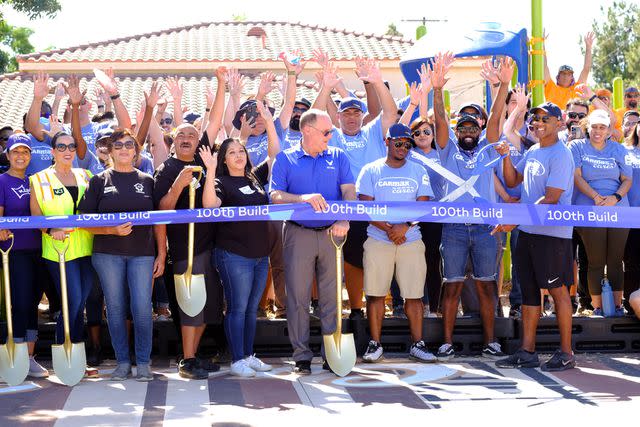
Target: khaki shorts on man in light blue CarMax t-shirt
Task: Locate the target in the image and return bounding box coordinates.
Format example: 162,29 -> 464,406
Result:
363,237 -> 427,299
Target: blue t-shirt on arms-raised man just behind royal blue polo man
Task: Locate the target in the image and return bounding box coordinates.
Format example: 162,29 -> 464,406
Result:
329,115 -> 387,176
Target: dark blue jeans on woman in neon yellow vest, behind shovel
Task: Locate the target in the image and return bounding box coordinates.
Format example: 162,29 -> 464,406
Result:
45,256 -> 95,344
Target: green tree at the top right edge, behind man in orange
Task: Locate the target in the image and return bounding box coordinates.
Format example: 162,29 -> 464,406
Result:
593,0 -> 640,88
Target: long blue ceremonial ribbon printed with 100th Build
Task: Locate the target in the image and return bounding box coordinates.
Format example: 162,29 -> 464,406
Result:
0,201 -> 640,230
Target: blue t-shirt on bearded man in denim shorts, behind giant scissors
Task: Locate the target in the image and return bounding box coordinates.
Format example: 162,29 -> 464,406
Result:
436,137 -> 500,203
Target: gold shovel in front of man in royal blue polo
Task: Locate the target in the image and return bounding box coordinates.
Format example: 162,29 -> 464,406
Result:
322,234 -> 356,377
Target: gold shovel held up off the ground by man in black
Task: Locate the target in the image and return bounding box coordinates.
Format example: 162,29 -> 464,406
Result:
173,166 -> 207,317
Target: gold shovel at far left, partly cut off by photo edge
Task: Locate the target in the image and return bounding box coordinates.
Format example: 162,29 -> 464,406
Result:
0,234 -> 29,386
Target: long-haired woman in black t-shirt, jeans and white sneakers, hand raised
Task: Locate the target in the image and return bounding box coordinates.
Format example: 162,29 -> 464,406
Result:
200,102 -> 280,377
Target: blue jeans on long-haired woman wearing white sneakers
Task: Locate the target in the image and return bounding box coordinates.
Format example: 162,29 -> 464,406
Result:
215,248 -> 269,362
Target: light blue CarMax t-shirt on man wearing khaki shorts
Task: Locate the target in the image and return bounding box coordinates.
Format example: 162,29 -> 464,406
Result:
356,157 -> 433,243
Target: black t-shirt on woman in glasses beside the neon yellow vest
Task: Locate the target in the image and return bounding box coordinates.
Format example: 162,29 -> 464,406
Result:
78,169 -> 156,256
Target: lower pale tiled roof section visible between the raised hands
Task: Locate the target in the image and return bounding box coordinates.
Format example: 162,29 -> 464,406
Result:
0,73 -> 364,128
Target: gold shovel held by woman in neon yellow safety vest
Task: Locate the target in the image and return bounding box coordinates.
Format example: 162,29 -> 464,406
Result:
51,238 -> 87,386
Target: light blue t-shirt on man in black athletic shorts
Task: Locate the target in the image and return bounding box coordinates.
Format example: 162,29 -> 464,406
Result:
516,141 -> 575,239
